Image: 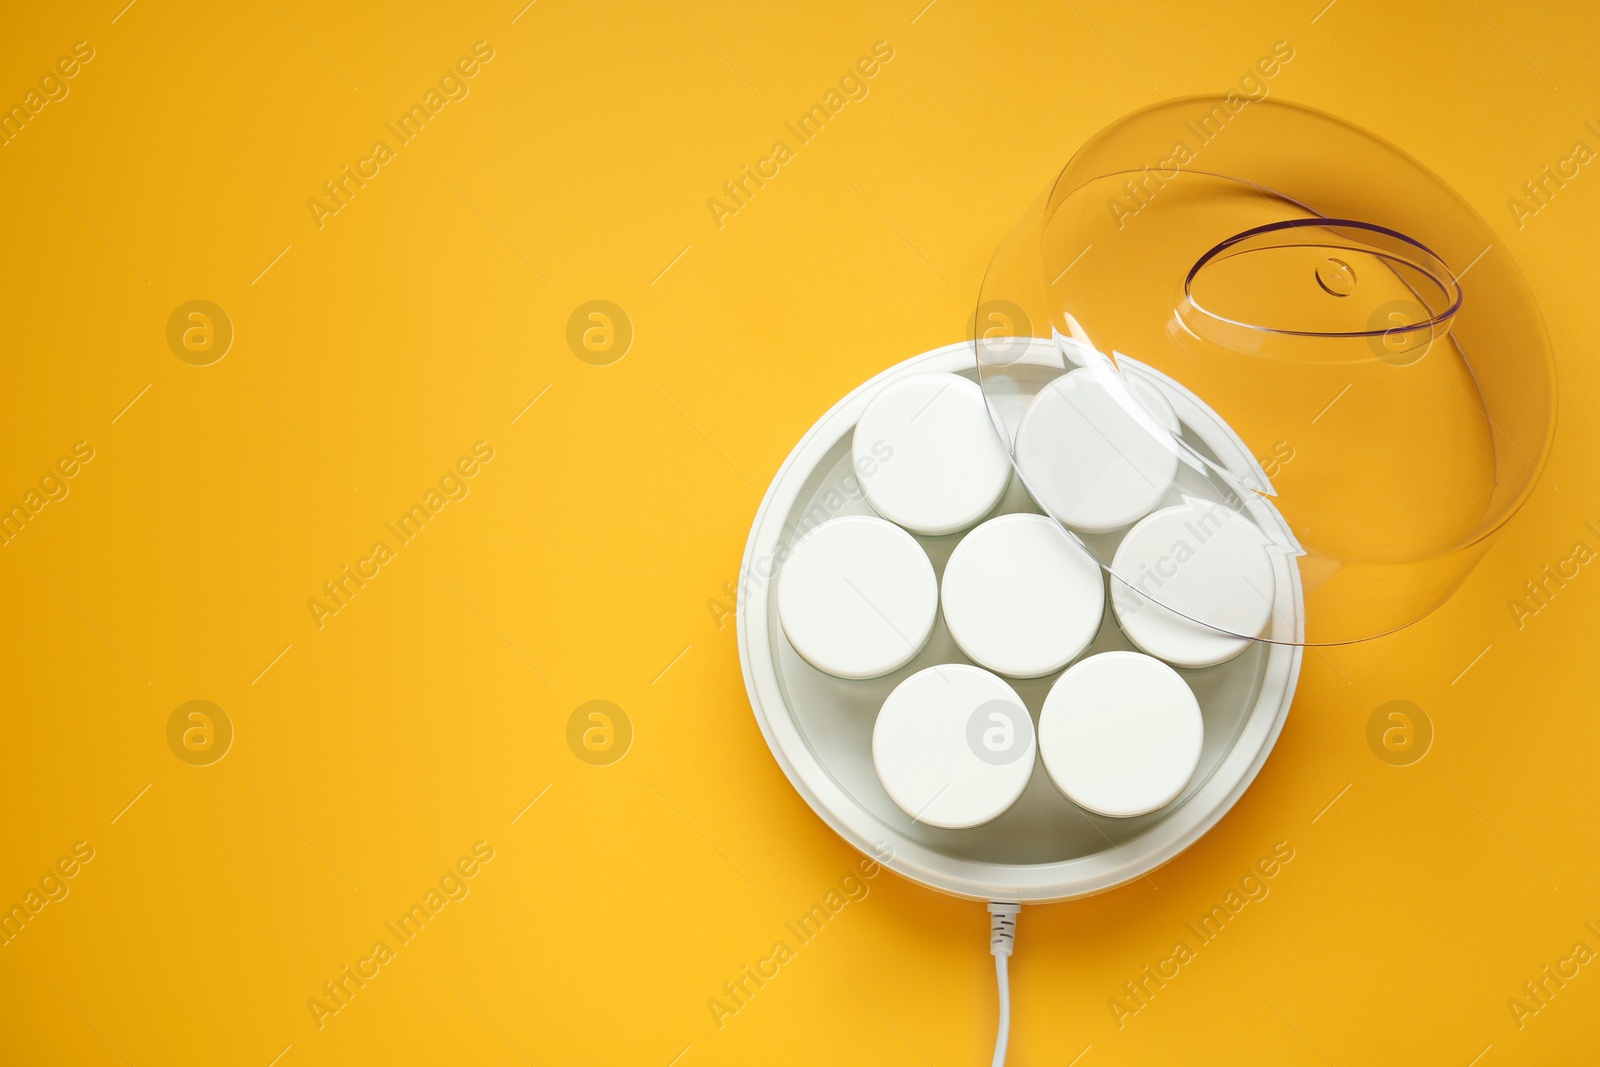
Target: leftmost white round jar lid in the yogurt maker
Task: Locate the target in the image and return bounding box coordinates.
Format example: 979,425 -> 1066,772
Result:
778,515 -> 939,678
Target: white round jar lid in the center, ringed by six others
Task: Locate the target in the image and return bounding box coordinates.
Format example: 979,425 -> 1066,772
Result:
939,514 -> 1106,678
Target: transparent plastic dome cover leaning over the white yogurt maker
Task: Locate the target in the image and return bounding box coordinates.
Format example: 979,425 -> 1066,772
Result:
973,96 -> 1555,646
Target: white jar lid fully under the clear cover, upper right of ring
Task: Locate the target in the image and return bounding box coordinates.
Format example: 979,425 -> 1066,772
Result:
1016,368 -> 1178,533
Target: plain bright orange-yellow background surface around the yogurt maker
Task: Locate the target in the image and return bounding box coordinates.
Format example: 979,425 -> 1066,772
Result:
0,0 -> 1600,1067
